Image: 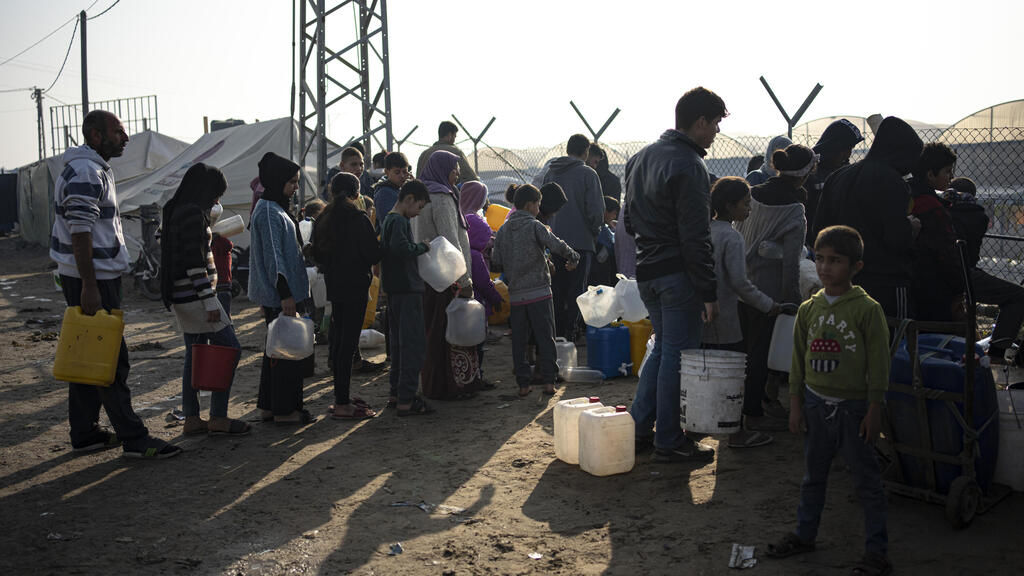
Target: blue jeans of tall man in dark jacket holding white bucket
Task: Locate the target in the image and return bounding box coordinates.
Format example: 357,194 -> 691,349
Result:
630,272 -> 703,450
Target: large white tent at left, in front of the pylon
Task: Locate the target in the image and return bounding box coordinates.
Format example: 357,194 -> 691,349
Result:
118,118 -> 337,213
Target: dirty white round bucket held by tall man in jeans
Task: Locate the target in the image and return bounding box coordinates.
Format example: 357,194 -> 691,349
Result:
679,349 -> 746,434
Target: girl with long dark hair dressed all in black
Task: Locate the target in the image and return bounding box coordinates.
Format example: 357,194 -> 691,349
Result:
313,172 -> 381,420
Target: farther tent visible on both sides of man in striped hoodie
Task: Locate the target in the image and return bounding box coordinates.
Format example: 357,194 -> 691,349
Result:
17,130 -> 188,246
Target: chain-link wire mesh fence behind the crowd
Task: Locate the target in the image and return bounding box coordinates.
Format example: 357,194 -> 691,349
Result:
403,126 -> 1024,283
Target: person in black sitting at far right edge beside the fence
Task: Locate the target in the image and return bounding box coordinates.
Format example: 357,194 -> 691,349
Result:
943,178 -> 1024,365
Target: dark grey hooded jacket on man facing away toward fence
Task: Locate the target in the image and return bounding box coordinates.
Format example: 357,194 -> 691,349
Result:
544,156 -> 604,252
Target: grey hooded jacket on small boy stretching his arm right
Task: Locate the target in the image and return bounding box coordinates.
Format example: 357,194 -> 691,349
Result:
490,210 -> 580,304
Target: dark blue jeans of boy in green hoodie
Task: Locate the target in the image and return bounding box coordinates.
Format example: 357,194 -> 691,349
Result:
797,388 -> 889,556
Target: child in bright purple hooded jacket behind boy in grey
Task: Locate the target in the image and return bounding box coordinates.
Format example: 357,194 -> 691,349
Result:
459,180 -> 502,389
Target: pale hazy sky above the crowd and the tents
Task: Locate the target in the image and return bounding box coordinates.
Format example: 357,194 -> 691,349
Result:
0,0 -> 1024,169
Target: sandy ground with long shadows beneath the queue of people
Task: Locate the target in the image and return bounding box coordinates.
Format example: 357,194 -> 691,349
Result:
0,238 -> 1024,575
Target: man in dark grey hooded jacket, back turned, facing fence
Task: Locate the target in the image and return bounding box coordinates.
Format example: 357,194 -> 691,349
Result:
544,134 -> 604,342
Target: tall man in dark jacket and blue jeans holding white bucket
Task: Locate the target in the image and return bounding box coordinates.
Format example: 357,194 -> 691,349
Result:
625,87 -> 728,462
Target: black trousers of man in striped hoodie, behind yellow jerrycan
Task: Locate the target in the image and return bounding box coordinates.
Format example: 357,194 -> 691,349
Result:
60,275 -> 150,447
